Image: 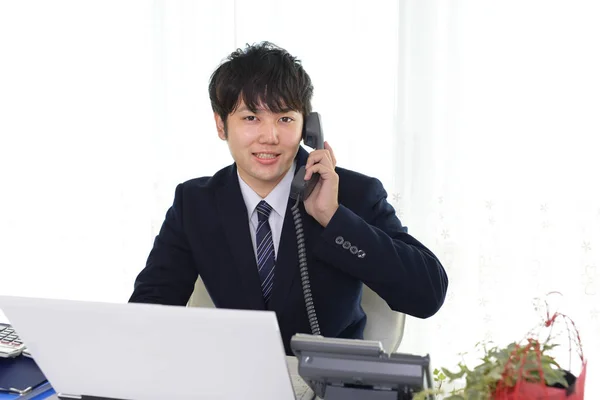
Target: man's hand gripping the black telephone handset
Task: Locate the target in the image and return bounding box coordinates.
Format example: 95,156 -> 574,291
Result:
304,142 -> 340,227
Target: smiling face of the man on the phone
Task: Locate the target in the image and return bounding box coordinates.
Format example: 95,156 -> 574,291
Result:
215,101 -> 303,197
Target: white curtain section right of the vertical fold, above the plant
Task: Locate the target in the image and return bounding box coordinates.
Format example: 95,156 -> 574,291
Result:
394,1 -> 600,398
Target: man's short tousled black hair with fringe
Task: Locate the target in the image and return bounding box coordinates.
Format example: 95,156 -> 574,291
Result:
208,42 -> 313,129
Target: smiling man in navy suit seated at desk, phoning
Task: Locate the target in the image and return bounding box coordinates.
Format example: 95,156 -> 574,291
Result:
130,43 -> 448,354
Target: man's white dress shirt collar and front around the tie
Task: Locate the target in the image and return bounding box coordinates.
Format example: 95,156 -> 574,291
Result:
238,161 -> 296,262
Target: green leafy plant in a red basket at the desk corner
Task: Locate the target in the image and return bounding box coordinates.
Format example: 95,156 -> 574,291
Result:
414,304 -> 586,400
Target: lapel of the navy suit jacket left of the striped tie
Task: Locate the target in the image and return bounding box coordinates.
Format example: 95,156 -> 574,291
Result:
216,166 -> 264,310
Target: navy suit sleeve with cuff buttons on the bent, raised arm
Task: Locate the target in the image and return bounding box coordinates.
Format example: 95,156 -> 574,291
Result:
315,179 -> 448,318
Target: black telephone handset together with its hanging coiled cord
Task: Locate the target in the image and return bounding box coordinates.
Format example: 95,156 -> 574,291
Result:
290,112 -> 325,335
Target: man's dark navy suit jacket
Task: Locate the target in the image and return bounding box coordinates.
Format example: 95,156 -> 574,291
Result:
129,148 -> 448,354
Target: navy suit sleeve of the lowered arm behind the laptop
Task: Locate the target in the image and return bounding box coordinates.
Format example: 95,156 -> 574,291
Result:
129,185 -> 198,306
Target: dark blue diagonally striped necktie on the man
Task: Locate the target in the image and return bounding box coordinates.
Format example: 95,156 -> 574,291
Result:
256,200 -> 275,304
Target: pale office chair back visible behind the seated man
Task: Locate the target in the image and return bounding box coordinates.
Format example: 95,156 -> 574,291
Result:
187,277 -> 406,353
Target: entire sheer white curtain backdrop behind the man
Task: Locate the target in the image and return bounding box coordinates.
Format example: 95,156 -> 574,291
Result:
0,0 -> 600,398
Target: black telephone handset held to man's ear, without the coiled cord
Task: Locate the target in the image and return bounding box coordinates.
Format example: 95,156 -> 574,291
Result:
290,112 -> 325,201
